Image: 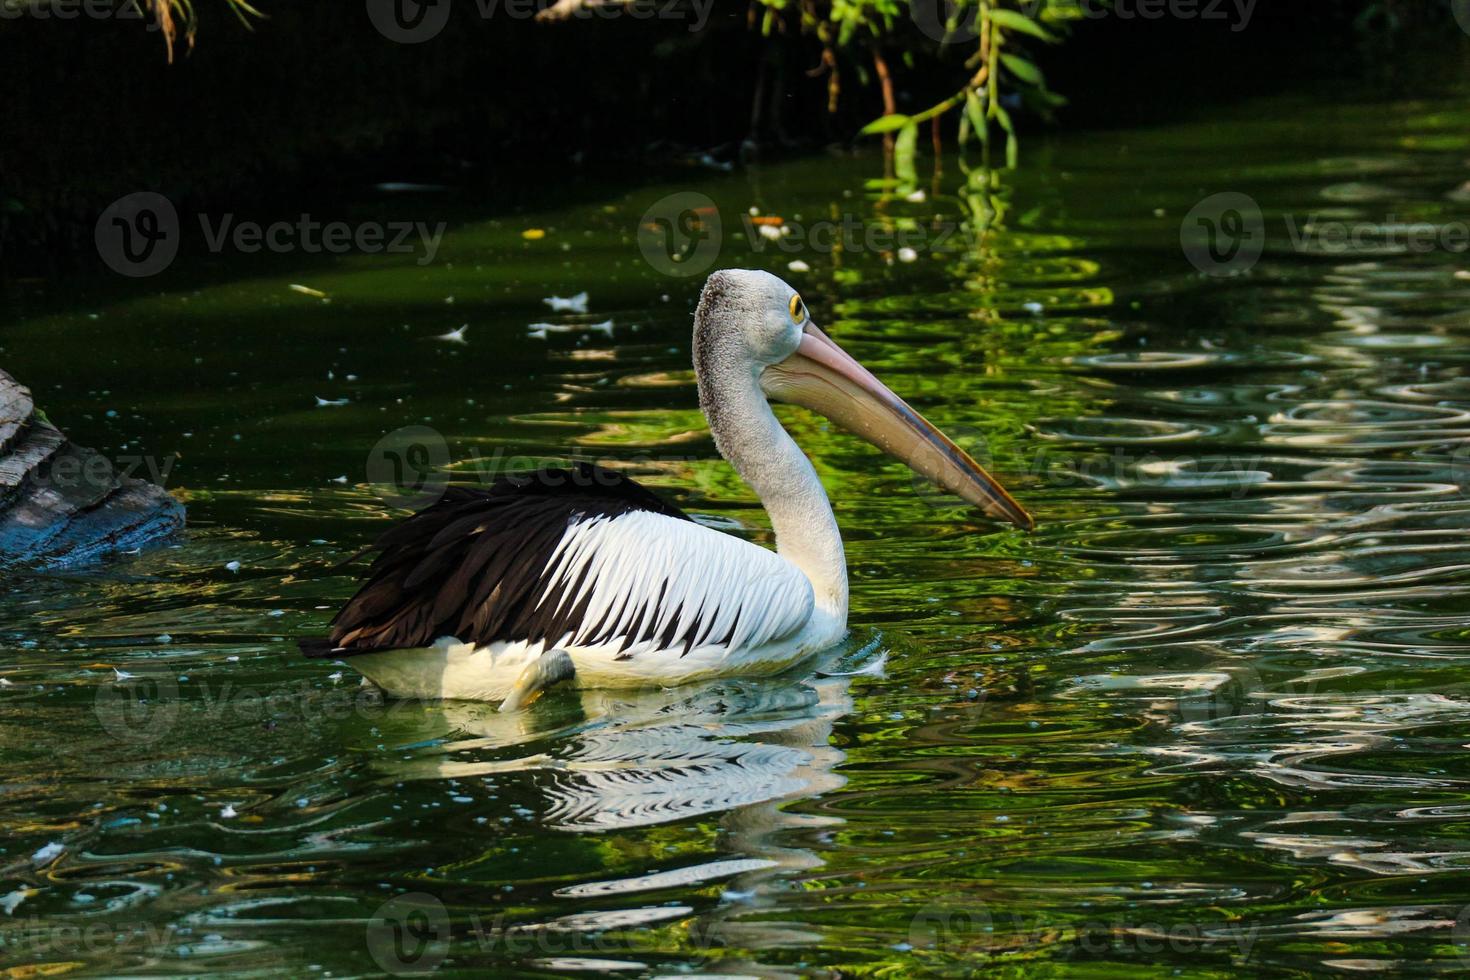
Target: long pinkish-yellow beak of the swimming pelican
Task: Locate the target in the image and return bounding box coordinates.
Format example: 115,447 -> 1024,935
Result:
760,320 -> 1036,530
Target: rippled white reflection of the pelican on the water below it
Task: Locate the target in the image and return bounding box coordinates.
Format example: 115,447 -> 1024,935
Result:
361,639 -> 883,948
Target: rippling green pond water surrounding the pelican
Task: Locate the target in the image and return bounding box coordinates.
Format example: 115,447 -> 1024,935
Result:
0,89 -> 1470,977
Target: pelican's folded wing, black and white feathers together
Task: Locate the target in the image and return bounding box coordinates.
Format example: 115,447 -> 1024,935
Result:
301,464 -> 811,657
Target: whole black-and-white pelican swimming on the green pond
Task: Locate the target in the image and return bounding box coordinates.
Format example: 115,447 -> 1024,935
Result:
301,270 -> 1033,711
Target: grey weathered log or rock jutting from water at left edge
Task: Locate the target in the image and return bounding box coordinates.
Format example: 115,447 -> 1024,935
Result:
0,370 -> 184,569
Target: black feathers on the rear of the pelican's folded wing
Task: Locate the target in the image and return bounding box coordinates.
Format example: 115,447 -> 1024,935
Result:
300,463 -> 688,657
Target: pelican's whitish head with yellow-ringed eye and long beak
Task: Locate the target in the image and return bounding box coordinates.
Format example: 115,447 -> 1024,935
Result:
694,269 -> 1035,529
